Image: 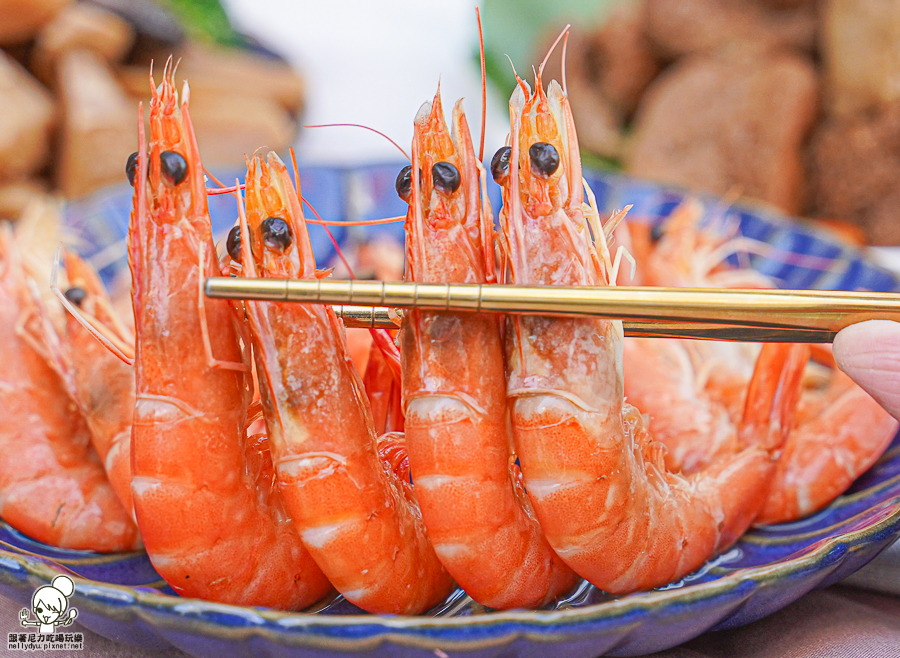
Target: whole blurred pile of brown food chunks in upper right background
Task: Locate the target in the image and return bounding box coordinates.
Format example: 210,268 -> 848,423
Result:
537,0 -> 900,244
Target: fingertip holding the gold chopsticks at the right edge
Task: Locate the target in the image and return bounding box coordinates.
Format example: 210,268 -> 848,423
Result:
834,320 -> 900,419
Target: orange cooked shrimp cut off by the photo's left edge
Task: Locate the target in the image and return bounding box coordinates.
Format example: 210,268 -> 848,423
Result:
0,223 -> 140,552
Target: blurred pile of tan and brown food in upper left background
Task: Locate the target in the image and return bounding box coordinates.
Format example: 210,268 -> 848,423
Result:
0,0 -> 304,209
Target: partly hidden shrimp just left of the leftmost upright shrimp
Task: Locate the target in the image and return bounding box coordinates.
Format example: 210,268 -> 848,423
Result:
53,252 -> 135,518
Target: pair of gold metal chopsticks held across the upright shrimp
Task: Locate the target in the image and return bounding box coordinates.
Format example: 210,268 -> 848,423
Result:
206,277 -> 900,342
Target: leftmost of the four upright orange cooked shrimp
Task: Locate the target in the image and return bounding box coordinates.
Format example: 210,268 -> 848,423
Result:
128,67 -> 330,609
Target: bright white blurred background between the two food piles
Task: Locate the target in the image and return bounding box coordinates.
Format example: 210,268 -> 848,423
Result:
223,0 -> 512,164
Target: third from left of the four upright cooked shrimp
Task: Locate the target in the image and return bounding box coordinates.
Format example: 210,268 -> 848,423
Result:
397,92 -> 576,608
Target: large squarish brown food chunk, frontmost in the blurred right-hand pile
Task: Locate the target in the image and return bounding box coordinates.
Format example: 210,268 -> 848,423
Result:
625,52 -> 818,213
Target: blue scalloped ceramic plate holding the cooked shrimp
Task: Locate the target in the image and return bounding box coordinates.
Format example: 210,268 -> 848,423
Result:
0,165 -> 900,658
